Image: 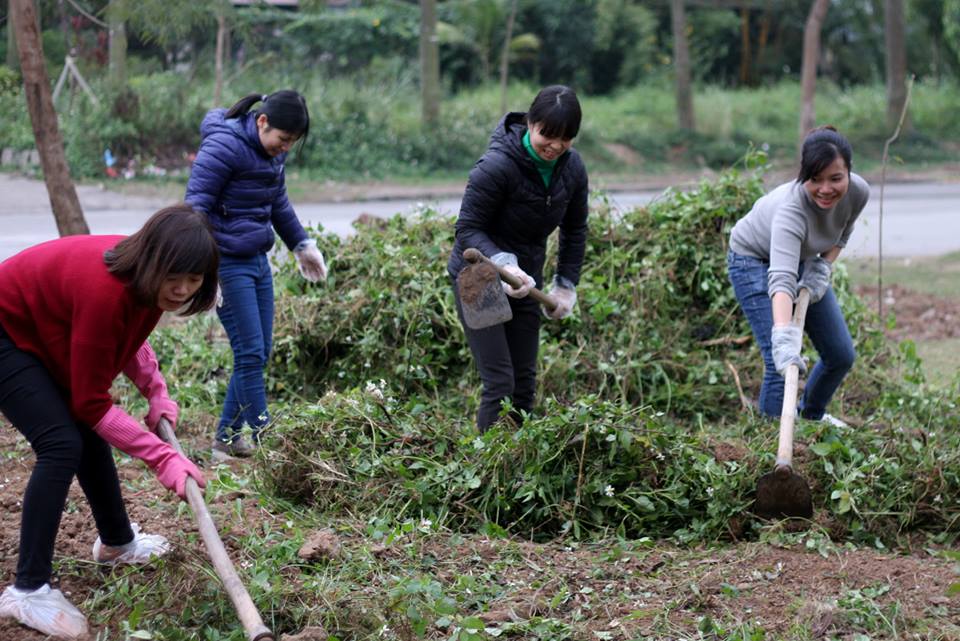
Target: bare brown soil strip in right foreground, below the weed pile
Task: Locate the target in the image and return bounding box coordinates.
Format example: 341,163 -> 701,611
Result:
404,539 -> 960,639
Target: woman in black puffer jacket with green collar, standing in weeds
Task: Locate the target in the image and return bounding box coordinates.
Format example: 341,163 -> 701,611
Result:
447,85 -> 588,432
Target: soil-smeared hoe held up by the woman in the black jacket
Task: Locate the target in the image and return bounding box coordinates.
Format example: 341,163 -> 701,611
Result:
457,247 -> 557,329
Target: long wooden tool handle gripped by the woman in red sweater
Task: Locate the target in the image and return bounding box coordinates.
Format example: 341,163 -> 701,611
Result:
157,418 -> 276,641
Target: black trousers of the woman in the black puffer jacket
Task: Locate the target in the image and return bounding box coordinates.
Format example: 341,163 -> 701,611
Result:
453,284 -> 541,432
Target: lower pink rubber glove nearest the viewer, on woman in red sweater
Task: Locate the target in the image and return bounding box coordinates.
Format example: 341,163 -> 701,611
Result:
93,405 -> 207,499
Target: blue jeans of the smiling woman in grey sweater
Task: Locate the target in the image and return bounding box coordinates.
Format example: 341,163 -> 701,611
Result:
727,251 -> 855,420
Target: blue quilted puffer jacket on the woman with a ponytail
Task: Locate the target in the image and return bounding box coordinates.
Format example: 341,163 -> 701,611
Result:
184,109 -> 307,256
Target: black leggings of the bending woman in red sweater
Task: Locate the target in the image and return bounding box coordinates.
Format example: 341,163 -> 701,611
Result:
0,327 -> 133,590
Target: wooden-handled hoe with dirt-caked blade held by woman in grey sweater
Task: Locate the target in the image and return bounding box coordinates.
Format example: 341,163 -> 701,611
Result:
754,289 -> 813,519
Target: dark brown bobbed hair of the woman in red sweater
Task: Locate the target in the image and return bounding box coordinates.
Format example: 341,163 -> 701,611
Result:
103,203 -> 220,316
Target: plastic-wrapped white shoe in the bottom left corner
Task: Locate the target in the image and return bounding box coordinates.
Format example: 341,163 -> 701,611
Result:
0,583 -> 87,639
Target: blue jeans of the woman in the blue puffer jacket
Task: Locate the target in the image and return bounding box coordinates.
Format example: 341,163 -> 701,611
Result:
217,254 -> 273,443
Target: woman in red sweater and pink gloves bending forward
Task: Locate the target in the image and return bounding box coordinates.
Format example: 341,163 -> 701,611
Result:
0,205 -> 219,638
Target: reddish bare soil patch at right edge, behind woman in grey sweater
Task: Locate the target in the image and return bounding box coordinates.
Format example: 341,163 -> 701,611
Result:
856,285 -> 960,341
